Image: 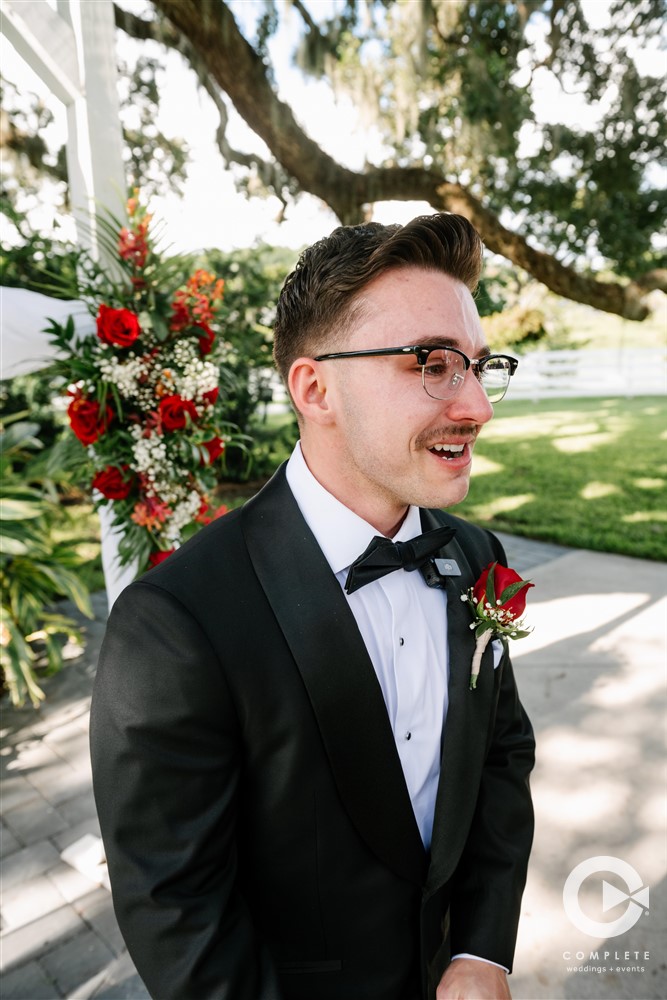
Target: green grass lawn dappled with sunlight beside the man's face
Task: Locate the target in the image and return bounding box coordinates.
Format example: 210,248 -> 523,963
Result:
453,397 -> 667,560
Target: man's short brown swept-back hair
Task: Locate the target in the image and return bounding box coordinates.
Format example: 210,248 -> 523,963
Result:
273,213 -> 483,382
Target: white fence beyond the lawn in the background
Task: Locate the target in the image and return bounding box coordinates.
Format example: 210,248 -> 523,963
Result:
507,347 -> 667,400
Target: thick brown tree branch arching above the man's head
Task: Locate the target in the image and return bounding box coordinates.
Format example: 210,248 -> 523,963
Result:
144,0 -> 664,320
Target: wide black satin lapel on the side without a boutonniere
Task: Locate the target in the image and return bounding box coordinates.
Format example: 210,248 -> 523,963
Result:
242,467 -> 426,884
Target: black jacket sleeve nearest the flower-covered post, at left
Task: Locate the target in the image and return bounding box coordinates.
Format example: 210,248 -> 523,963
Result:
91,582 -> 280,1000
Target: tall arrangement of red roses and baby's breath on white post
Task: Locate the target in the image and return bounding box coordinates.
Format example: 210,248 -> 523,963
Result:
50,197 -> 233,570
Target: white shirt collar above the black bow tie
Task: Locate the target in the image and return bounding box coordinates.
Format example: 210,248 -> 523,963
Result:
286,441 -> 422,574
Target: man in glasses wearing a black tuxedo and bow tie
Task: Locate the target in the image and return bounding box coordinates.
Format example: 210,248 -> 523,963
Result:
91,215 -> 534,1000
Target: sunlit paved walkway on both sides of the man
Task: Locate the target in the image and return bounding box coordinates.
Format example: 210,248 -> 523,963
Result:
0,536 -> 667,1000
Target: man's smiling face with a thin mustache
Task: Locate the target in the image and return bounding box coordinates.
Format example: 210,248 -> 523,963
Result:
304,267 -> 493,534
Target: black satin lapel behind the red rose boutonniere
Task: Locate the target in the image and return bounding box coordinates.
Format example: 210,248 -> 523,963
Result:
422,511 -> 494,891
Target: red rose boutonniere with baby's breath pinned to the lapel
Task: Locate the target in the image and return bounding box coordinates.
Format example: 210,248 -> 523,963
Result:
461,562 -> 535,691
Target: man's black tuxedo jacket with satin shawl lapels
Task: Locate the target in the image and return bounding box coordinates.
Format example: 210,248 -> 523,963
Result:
91,469 -> 534,1000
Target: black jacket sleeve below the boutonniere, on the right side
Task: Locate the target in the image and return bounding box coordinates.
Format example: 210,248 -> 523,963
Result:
450,537 -> 535,970
